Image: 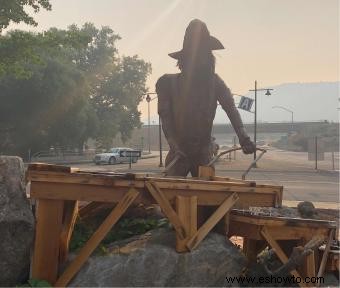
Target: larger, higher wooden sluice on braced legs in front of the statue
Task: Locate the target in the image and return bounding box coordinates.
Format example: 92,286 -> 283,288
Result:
27,164 -> 283,286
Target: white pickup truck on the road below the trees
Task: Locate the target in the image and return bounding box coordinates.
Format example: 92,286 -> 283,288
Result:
93,147 -> 138,165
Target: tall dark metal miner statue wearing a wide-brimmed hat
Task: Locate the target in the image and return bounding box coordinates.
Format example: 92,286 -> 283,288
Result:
156,19 -> 255,177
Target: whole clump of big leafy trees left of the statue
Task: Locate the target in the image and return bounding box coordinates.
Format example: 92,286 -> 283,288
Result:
0,23 -> 151,156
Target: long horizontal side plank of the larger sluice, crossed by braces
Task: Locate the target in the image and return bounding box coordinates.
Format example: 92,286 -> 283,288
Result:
31,181 -> 277,209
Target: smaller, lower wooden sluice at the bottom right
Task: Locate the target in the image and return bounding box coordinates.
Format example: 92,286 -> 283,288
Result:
228,209 -> 337,286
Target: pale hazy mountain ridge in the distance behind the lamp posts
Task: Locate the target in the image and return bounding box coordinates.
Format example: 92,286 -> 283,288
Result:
214,82 -> 340,123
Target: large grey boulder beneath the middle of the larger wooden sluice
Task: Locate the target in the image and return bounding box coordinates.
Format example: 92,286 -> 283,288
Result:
70,229 -> 246,287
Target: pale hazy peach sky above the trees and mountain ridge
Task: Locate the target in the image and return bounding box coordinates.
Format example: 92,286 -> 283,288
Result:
4,0 -> 339,119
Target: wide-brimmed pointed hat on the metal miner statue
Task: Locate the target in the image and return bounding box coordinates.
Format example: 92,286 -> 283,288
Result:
169,19 -> 224,60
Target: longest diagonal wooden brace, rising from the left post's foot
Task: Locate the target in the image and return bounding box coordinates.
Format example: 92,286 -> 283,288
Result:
54,188 -> 139,287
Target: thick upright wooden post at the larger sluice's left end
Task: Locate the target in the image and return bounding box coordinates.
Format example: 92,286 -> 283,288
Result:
32,200 -> 64,283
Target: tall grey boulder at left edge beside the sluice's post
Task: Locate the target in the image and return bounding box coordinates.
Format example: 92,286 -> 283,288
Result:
0,156 -> 34,286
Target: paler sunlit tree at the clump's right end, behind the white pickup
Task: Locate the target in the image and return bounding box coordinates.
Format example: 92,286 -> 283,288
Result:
92,56 -> 151,148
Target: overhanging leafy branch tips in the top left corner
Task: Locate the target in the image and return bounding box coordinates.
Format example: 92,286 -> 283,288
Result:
0,0 -> 52,33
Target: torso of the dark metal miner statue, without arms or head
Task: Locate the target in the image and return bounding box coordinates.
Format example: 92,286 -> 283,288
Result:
159,74 -> 217,154
